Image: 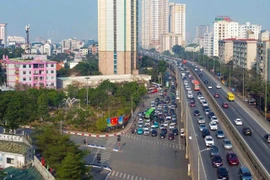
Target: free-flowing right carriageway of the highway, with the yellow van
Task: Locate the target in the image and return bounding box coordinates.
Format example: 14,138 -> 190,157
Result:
187,63 -> 270,176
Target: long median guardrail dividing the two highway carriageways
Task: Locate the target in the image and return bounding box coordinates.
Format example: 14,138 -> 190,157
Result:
190,65 -> 270,180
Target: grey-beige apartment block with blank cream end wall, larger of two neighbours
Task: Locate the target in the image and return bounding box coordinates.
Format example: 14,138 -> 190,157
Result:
233,39 -> 257,69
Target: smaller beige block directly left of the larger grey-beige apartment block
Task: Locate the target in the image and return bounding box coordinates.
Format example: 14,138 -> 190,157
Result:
219,38 -> 233,63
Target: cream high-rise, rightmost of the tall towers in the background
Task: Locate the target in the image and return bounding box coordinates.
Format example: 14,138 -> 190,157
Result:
169,3 -> 186,45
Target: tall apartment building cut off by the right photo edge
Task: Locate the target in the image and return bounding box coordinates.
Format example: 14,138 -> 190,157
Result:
256,31 -> 270,81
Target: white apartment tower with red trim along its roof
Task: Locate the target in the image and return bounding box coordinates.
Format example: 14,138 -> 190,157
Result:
213,16 -> 239,56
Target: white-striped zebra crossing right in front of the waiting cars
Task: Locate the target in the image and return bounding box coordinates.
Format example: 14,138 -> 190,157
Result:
123,134 -> 185,150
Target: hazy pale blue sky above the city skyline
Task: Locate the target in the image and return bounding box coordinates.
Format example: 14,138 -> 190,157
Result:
0,0 -> 270,41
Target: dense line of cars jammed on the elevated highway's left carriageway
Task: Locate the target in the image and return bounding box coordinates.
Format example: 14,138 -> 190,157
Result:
182,64 -> 252,179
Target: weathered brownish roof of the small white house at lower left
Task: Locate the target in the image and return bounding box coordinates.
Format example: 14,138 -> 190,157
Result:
0,140 -> 29,154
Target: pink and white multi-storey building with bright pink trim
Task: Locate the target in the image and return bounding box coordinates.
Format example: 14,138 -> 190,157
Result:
3,56 -> 57,89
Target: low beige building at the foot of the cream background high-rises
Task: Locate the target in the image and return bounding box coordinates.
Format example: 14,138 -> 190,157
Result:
161,33 -> 183,53
